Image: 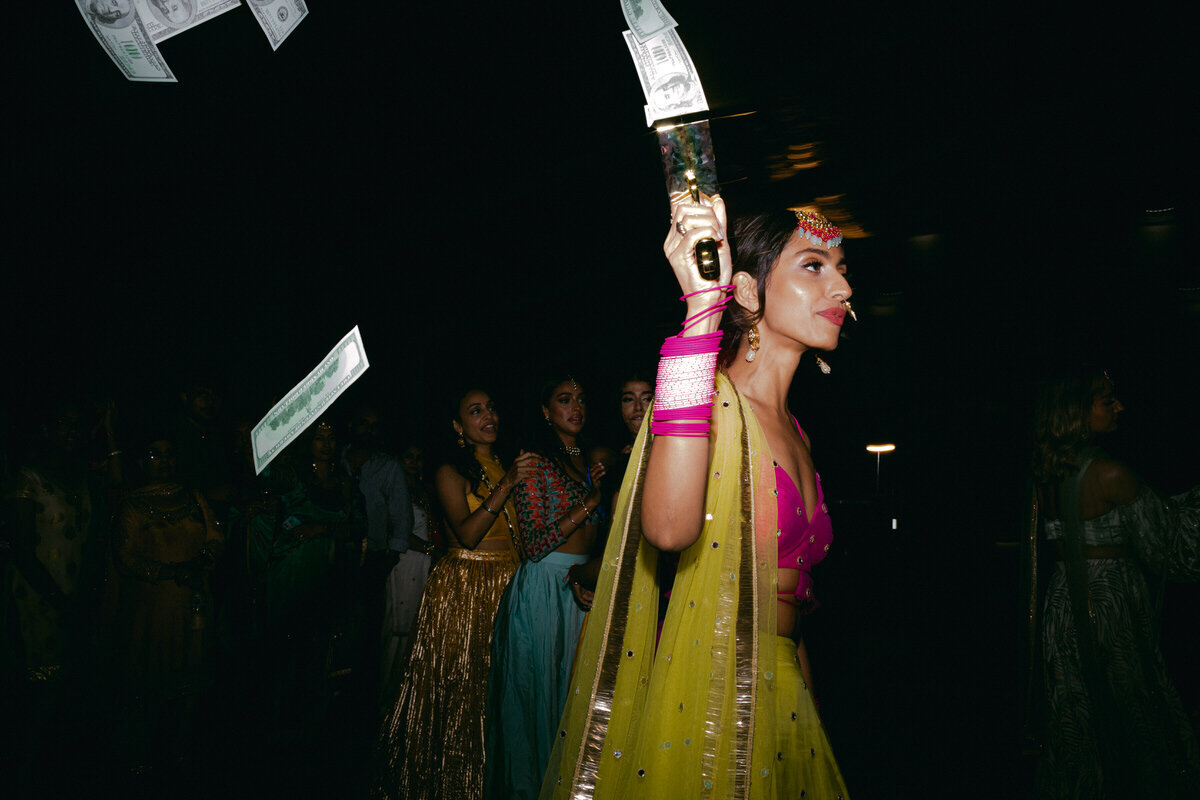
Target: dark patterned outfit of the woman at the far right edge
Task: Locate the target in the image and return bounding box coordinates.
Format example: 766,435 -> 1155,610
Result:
1031,451 -> 1200,799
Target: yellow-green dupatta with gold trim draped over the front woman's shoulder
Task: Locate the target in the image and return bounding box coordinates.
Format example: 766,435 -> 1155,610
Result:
541,374 -> 778,800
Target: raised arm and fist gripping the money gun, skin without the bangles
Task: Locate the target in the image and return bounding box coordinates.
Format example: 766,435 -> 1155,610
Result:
642,197 -> 732,551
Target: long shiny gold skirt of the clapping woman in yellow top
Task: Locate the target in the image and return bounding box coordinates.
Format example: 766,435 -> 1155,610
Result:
370,549 -> 517,800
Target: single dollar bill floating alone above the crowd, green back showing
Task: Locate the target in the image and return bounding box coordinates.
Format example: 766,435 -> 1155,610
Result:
250,325 -> 371,475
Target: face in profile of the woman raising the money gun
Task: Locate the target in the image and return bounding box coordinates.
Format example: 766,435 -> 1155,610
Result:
758,234 -> 853,350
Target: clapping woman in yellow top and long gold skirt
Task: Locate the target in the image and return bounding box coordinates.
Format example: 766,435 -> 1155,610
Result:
370,389 -> 533,800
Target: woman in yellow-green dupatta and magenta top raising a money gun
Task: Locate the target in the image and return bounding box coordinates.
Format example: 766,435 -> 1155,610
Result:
541,198 -> 851,800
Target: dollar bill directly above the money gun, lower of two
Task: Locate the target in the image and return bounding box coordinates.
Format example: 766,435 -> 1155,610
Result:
623,28 -> 708,127
